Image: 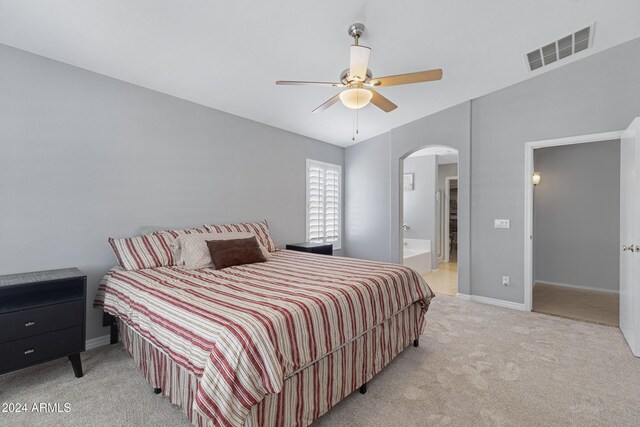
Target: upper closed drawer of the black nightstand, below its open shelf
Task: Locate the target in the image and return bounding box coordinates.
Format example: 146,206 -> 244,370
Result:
0,300 -> 84,343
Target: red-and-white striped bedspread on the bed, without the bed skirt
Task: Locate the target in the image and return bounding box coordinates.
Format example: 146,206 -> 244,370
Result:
94,251 -> 432,425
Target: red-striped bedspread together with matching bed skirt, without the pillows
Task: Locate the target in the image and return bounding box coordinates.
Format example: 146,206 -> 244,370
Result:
94,239 -> 433,426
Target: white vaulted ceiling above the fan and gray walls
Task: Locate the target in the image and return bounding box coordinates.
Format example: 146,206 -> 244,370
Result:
0,0 -> 640,146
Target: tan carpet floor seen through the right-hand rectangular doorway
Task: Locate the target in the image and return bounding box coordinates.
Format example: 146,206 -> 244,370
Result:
533,283 -> 620,328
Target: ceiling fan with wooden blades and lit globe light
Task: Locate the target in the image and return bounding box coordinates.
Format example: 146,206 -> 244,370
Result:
276,23 -> 442,113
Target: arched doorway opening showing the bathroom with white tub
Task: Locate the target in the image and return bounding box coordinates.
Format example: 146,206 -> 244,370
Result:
400,146 -> 458,296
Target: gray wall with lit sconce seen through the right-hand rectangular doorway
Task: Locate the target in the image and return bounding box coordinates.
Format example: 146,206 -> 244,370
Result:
533,140 -> 620,291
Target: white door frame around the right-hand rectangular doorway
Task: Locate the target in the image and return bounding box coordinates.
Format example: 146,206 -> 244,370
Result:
523,130 -> 624,311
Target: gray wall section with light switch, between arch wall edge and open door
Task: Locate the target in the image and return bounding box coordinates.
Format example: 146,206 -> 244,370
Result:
471,39 -> 640,303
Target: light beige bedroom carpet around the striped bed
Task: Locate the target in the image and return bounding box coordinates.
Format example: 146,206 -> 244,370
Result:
0,296 -> 640,427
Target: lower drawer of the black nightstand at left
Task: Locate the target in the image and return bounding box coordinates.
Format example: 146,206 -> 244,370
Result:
0,326 -> 83,374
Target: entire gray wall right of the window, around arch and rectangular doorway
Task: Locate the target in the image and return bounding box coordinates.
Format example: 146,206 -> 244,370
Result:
345,39 -> 640,303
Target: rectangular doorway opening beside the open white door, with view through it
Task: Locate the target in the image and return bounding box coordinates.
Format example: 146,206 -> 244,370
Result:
532,140 -> 620,326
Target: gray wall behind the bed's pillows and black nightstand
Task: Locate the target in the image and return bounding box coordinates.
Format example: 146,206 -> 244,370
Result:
0,45 -> 344,338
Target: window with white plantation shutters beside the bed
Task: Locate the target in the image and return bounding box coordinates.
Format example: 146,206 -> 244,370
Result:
307,159 -> 342,249
